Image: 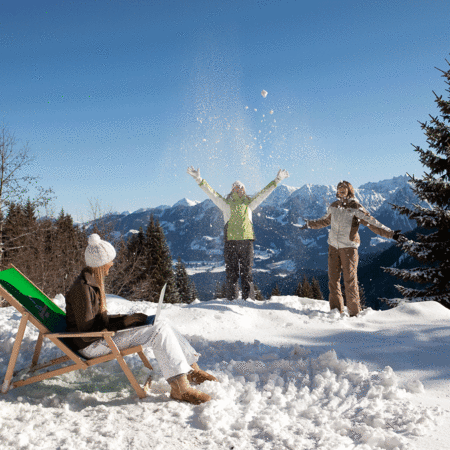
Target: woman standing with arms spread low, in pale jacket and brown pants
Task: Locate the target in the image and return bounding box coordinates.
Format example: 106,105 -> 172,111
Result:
302,181 -> 402,316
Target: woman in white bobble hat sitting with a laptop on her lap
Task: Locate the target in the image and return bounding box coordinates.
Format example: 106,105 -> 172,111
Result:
66,234 -> 217,404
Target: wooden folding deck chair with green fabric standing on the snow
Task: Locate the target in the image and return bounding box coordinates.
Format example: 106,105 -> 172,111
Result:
0,265 -> 153,398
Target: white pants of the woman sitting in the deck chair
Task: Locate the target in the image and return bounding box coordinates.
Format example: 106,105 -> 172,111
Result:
79,319 -> 200,380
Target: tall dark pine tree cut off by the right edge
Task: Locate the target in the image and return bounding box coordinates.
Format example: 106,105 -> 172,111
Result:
382,61 -> 450,308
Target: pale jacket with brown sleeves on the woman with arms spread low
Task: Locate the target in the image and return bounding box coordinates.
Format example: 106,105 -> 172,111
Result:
307,197 -> 394,249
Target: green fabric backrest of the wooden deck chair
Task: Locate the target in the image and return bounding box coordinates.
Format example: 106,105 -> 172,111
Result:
0,267 -> 66,333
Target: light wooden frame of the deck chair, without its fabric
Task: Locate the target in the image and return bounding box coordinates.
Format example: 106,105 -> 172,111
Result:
0,264 -> 153,398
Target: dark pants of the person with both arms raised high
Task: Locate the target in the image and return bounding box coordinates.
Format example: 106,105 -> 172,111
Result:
223,240 -> 255,300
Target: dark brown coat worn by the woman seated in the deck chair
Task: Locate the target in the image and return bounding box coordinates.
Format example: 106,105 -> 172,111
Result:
66,268 -> 135,350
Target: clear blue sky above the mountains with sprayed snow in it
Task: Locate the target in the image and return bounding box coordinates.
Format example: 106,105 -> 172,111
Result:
0,0 -> 450,220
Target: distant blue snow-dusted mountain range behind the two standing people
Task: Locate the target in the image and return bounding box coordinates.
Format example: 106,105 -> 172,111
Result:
94,176 -> 420,300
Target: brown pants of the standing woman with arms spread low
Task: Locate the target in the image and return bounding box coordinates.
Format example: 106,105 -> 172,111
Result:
328,245 -> 361,316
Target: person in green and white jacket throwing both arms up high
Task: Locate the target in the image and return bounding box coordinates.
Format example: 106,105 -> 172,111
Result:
187,167 -> 289,300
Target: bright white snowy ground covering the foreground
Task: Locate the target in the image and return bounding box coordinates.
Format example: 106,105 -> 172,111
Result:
0,296 -> 450,450
